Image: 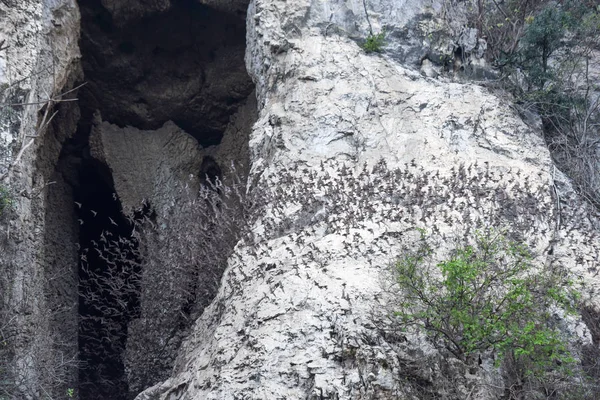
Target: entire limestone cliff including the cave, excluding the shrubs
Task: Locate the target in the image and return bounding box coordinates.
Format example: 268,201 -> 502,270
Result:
0,0 -> 600,400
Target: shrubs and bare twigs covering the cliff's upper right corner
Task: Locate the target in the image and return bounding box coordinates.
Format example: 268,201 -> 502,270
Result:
488,0 -> 600,209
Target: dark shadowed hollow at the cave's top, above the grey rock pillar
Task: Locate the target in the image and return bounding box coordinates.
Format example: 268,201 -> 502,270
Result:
80,0 -> 254,147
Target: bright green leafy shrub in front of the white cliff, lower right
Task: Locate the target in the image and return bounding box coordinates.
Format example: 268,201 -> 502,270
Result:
395,231 -> 577,376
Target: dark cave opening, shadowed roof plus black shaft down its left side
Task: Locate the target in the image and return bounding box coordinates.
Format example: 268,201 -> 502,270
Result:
63,0 -> 254,400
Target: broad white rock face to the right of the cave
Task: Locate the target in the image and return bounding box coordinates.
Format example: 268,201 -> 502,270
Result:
137,0 -> 600,400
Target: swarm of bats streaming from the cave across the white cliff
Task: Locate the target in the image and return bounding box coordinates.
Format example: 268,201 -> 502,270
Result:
75,160 -> 600,391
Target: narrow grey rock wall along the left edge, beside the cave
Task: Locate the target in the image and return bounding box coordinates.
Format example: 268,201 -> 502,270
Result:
0,0 -> 80,399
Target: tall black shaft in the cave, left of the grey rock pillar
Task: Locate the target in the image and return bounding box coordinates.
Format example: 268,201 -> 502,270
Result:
73,152 -> 141,400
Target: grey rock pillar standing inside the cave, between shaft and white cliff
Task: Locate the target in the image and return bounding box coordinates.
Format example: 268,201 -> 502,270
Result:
90,92 -> 256,394
